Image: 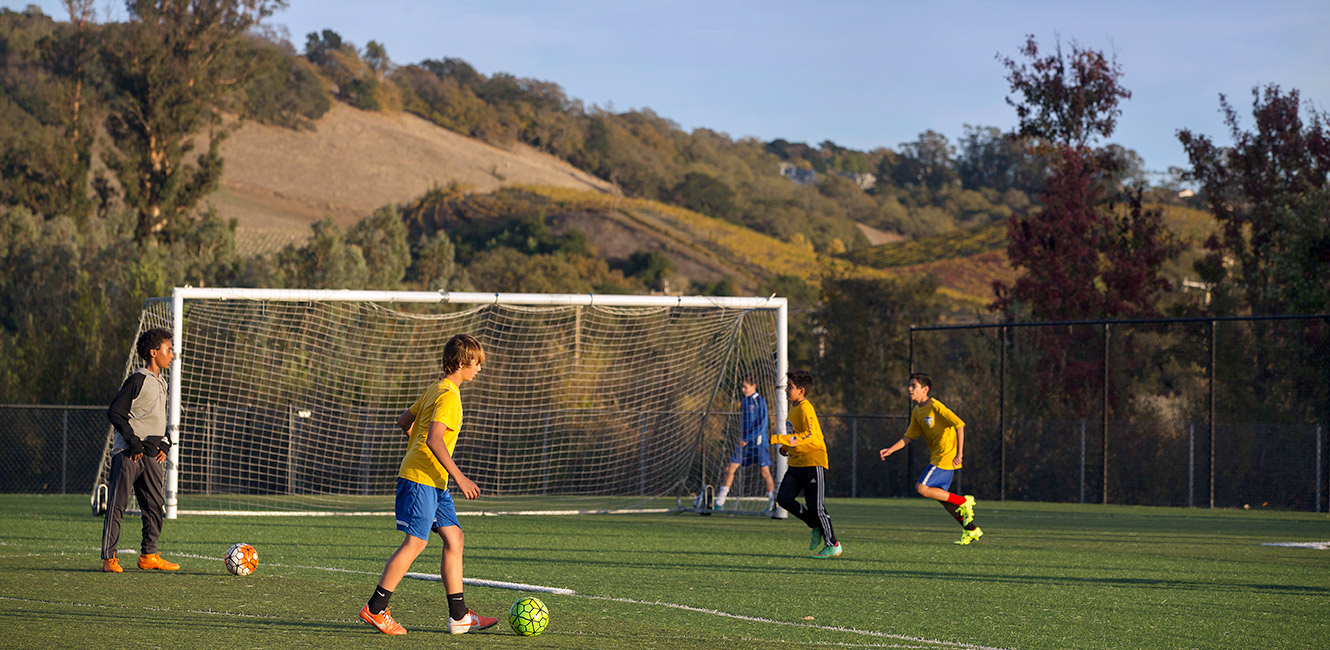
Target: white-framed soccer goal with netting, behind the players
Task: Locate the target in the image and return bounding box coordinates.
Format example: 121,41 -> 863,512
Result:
93,287 -> 787,517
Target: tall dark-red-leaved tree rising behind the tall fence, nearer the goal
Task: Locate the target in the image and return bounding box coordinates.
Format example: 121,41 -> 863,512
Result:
990,36 -> 1178,320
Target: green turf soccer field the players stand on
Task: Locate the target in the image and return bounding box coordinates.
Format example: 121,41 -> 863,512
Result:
0,494 -> 1330,650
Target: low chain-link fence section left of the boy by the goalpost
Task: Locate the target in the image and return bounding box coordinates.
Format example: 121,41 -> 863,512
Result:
0,404 -> 110,494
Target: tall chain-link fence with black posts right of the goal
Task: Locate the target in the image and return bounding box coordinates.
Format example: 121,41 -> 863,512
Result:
910,315 -> 1330,512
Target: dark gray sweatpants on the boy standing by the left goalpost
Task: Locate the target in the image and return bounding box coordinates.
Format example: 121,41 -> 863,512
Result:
101,452 -> 166,560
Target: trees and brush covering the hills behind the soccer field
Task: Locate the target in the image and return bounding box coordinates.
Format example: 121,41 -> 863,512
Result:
0,0 -> 1330,425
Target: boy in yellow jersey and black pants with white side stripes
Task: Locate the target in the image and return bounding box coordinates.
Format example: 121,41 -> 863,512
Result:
771,371 -> 841,558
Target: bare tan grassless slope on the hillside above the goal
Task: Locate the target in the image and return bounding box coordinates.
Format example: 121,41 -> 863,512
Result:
207,104 -> 617,250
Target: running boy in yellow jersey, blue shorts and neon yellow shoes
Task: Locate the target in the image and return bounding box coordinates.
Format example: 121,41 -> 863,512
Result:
879,372 -> 984,545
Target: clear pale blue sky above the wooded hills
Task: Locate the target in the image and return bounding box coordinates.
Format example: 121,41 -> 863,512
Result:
10,0 -> 1330,170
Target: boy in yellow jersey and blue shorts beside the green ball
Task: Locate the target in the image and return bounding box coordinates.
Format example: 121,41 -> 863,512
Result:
360,334 -> 499,634
